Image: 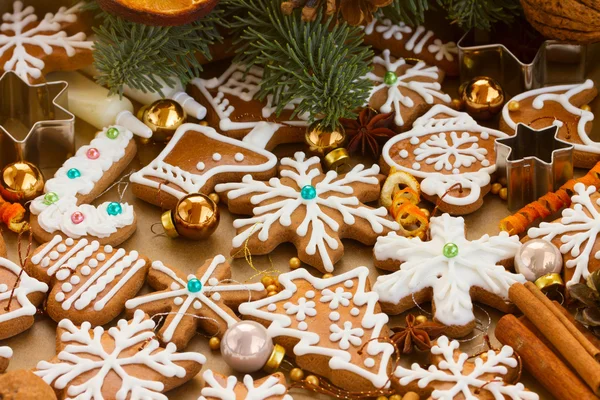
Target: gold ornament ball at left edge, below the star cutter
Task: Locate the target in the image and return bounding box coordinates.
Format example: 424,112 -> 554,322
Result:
0,161 -> 44,202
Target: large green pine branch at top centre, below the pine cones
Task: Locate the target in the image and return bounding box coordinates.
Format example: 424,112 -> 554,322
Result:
225,0 -> 373,127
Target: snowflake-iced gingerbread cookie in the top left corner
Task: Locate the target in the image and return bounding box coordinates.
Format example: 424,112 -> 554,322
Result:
0,1 -> 94,83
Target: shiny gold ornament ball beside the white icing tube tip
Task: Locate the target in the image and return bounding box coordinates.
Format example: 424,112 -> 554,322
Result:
140,99 -> 187,142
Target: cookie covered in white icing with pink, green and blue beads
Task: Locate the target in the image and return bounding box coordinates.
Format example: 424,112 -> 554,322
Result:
30,126 -> 137,246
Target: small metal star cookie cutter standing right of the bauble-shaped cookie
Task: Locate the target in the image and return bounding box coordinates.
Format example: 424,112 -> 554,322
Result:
495,123 -> 573,211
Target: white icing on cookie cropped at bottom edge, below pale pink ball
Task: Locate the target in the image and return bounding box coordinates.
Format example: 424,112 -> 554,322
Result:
198,369 -> 292,400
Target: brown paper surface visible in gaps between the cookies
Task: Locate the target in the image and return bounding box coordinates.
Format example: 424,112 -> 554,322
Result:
7,0 -> 598,400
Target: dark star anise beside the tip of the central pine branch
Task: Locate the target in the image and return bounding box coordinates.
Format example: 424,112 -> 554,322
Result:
340,107 -> 396,158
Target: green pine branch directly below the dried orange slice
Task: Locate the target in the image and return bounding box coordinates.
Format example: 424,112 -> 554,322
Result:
86,1 -> 222,95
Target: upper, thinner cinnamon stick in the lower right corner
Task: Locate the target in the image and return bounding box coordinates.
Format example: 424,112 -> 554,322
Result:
508,283 -> 600,394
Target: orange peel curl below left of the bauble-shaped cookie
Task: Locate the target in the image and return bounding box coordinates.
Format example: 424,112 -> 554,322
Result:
379,169 -> 429,238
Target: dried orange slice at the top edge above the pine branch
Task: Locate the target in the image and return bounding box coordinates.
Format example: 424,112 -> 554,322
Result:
98,0 -> 219,26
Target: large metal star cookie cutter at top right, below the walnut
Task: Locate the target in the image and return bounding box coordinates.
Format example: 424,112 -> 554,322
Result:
457,30 -> 597,96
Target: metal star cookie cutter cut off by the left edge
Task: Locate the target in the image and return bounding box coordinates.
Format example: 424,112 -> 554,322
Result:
0,71 -> 75,169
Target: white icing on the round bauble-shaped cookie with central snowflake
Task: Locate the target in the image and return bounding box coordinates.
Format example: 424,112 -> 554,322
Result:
382,104 -> 508,206
